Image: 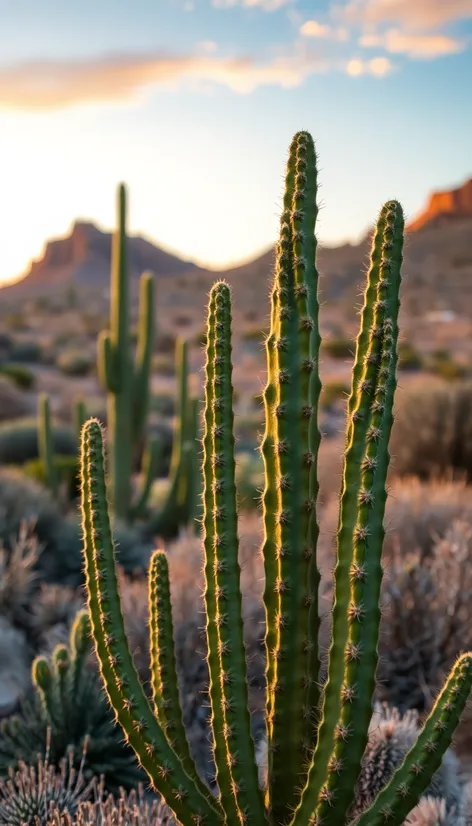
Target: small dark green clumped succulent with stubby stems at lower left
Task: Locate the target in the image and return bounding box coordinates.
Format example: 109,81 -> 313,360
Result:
0,610 -> 143,792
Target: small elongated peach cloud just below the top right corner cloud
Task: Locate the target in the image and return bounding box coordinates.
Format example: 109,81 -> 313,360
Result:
359,29 -> 466,60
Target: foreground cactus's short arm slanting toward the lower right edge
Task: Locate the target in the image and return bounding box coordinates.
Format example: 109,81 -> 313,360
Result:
355,653 -> 472,826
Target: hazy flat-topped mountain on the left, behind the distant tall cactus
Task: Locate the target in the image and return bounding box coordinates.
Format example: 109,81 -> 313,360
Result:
4,221 -> 206,292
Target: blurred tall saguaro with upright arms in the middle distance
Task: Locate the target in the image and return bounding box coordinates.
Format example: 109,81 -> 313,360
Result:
98,185 -> 197,533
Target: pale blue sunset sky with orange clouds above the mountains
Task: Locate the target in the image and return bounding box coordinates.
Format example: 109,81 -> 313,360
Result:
0,0 -> 472,281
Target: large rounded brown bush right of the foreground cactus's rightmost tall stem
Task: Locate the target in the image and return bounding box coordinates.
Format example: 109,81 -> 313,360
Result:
390,382 -> 472,481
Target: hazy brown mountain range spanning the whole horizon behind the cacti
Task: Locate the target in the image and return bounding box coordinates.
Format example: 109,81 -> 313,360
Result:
2,174 -> 472,318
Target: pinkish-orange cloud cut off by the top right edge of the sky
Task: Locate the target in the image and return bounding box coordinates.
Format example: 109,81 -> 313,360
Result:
336,0 -> 472,31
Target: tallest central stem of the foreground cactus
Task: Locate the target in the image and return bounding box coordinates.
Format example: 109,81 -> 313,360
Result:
269,133 -> 317,822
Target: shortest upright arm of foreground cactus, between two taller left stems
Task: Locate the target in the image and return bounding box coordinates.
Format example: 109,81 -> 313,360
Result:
149,551 -> 215,799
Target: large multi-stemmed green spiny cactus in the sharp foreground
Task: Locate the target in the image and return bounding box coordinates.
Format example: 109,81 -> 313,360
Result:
81,132 -> 472,826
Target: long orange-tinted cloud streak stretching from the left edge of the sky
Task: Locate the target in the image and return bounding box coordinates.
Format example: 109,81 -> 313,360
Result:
0,44 -> 329,109
